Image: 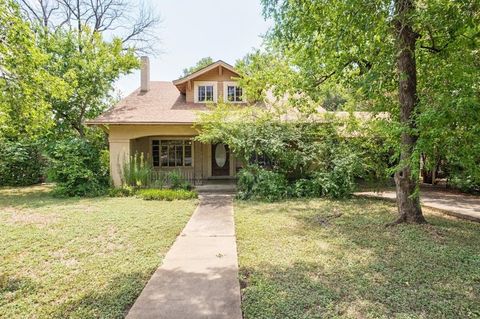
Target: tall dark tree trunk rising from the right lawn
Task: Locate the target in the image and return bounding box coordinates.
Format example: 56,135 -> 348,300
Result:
395,0 -> 426,223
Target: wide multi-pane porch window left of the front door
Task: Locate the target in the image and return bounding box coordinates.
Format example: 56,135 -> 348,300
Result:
152,140 -> 193,167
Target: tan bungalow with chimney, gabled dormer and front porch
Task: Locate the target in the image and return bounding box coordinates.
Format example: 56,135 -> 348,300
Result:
87,57 -> 245,186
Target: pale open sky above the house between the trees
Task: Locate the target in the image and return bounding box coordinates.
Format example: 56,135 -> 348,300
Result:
115,0 -> 271,96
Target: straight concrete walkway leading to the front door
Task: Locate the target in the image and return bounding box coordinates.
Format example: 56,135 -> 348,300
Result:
127,194 -> 242,319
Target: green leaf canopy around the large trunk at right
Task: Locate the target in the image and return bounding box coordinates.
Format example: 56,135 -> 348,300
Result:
260,0 -> 480,196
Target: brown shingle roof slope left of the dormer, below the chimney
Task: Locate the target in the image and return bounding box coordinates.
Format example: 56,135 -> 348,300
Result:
87,81 -> 207,124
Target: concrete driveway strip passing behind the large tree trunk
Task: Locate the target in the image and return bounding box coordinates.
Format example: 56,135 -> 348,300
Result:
355,189 -> 480,222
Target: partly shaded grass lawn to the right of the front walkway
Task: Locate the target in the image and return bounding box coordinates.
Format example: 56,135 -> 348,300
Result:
235,199 -> 480,319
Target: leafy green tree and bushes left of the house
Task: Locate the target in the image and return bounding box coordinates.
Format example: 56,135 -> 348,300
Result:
0,0 -> 139,196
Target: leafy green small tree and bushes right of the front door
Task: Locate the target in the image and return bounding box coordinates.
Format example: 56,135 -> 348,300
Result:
197,104 -> 391,201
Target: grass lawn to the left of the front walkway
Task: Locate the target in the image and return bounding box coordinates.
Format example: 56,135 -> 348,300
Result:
0,186 -> 196,318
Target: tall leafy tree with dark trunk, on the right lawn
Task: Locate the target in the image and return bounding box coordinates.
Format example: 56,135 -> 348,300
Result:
263,0 -> 480,223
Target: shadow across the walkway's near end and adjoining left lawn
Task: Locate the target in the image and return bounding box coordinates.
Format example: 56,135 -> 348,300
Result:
49,268 -> 239,318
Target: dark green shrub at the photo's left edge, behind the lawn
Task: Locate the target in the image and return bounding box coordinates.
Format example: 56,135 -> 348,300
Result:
0,140 -> 45,186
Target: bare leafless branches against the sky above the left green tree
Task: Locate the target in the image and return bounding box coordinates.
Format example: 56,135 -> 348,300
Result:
17,0 -> 161,54
